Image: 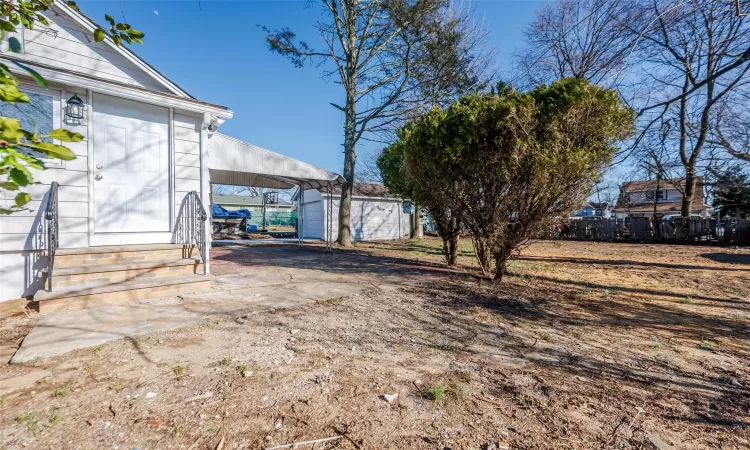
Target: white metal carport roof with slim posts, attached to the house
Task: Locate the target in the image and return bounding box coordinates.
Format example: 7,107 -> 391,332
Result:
206,133 -> 344,250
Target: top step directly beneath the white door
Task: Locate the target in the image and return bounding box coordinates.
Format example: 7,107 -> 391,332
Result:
54,244 -> 198,270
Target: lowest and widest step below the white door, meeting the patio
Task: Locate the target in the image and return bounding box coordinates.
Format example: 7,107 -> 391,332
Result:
31,274 -> 213,313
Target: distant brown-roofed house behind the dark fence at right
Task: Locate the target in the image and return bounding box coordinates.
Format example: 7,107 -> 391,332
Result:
613,178 -> 711,219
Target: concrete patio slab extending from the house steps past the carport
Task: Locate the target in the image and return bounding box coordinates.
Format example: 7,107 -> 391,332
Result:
11,243 -> 451,363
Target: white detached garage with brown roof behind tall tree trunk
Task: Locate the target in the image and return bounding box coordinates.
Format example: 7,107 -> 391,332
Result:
292,183 -> 412,241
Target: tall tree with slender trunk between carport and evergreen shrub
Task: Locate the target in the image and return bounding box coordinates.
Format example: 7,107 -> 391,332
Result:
264,0 -> 490,246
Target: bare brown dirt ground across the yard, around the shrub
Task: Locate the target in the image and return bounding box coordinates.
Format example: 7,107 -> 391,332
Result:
0,239 -> 750,450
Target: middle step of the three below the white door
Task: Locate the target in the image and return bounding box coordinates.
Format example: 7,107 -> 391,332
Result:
52,258 -> 203,290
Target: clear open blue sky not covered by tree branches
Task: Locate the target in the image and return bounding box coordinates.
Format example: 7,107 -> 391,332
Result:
78,0 -> 543,173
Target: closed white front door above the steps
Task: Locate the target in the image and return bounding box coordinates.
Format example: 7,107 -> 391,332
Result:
91,94 -> 171,245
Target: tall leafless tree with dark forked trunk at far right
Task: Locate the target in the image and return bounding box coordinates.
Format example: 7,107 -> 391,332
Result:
632,0 -> 750,217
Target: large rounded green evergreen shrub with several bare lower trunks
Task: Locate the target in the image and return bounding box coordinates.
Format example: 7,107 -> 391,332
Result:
379,78 -> 635,280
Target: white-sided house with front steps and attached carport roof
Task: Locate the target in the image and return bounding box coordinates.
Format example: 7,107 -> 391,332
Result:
0,0 -> 343,310
